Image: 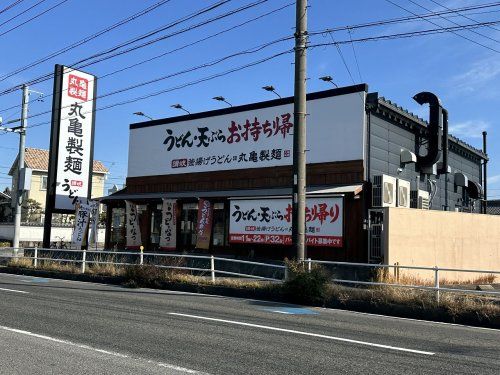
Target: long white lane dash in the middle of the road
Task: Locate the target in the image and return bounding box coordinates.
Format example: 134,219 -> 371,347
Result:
168,313 -> 436,355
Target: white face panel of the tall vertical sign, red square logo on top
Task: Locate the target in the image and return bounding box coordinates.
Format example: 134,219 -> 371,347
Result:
54,67 -> 95,210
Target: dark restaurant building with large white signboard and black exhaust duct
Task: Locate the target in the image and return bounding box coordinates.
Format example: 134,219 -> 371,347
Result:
102,84 -> 487,262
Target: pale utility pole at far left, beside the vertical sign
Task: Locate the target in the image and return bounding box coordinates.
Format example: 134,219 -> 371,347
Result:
12,85 -> 29,255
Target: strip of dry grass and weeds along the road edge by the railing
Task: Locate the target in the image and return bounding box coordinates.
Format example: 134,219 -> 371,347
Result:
2,258 -> 500,324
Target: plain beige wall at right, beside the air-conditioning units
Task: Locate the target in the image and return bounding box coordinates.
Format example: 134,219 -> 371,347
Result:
384,208 -> 500,280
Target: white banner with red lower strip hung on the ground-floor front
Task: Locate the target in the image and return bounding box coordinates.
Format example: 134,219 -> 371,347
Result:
229,197 -> 343,247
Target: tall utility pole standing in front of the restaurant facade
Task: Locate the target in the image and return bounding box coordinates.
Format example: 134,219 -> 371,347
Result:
292,0 -> 307,260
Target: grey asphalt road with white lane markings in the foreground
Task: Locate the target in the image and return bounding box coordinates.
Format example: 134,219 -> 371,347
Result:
0,274 -> 500,375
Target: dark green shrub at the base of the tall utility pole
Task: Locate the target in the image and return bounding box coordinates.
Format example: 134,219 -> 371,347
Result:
283,260 -> 330,304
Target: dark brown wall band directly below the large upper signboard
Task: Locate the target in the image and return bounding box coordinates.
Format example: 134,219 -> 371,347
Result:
127,160 -> 363,193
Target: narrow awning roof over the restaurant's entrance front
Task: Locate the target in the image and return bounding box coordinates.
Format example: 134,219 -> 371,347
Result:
98,184 -> 363,203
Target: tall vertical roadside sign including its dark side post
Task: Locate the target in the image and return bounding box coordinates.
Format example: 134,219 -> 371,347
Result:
43,65 -> 97,248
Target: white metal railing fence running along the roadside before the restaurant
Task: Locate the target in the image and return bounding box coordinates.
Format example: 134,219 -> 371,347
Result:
0,247 -> 500,301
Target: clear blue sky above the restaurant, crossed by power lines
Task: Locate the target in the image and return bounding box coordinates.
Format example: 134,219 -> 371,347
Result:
0,0 -> 500,199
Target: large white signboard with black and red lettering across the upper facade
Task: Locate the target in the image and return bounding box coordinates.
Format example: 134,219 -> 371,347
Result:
128,91 -> 366,177
